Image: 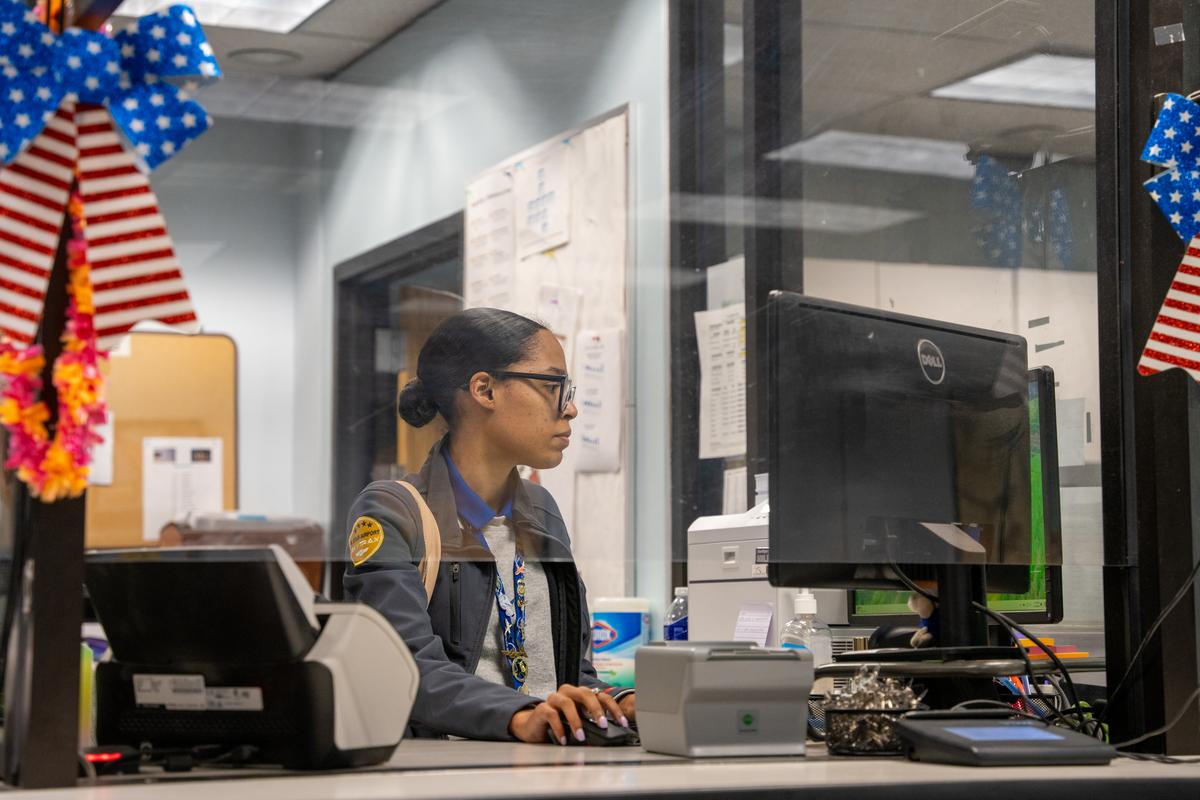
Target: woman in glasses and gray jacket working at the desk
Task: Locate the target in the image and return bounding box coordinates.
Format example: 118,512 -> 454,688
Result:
344,308 -> 635,745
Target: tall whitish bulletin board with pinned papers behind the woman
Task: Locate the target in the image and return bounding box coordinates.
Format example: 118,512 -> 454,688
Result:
463,107 -> 634,596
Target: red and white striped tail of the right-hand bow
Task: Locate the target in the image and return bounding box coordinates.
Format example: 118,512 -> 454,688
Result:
1138,236 -> 1200,380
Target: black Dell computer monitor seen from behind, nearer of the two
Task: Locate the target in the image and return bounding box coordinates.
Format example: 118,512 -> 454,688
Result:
767,291 -> 1046,644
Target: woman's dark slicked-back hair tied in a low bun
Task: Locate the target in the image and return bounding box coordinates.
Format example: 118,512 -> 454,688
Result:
397,308 -> 546,428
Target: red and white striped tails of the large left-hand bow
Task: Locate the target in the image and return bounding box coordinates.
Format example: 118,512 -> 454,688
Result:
0,103 -> 199,350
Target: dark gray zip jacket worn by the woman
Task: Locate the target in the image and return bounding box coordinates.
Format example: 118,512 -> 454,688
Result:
343,439 -> 608,740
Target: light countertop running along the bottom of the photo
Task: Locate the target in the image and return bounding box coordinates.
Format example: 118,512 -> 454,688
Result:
18,741 -> 1200,800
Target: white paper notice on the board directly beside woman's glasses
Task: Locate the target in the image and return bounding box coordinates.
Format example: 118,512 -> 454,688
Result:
575,329 -> 624,473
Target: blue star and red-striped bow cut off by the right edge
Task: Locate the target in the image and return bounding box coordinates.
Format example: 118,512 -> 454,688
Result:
1138,94 -> 1200,381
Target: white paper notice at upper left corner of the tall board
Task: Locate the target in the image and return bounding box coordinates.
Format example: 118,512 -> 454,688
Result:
463,170 -> 516,308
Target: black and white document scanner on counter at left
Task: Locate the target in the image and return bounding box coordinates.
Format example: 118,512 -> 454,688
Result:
86,545 -> 419,769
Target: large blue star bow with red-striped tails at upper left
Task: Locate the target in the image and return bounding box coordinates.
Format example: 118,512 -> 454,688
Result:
0,0 -> 221,350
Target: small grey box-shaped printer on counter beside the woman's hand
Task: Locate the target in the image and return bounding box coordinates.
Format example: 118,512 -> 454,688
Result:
635,642 -> 812,758
